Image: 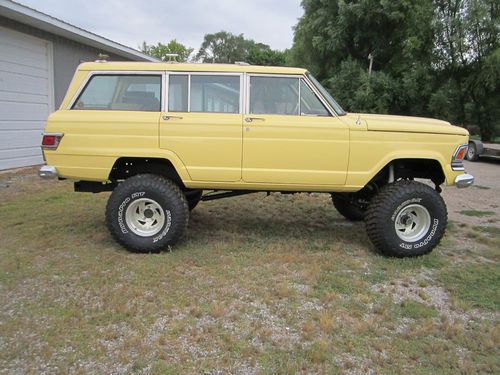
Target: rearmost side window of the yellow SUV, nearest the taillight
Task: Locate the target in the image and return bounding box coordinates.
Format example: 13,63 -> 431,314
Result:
72,74 -> 161,112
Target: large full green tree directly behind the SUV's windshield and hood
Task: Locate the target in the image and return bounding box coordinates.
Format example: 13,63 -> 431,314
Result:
292,0 -> 433,114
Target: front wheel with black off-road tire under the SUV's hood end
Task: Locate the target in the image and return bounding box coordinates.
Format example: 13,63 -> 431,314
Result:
366,181 -> 448,257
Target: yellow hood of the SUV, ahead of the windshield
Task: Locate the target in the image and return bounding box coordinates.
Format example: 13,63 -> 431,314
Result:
347,113 -> 469,135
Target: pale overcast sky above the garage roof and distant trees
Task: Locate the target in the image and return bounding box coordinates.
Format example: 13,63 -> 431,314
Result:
15,0 -> 303,50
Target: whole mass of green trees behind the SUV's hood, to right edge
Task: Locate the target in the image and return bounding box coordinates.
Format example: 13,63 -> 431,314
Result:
290,0 -> 500,140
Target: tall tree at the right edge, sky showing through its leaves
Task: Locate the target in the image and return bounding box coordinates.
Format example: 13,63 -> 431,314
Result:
430,0 -> 500,141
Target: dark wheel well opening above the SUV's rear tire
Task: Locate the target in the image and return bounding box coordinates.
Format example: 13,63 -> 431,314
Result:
109,157 -> 185,188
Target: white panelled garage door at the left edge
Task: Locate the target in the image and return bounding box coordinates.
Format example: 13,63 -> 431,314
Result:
0,27 -> 53,170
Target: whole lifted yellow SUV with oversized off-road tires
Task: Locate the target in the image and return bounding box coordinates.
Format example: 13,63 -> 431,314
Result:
40,62 -> 474,257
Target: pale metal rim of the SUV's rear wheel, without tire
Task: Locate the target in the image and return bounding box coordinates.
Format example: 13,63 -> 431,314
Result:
125,198 -> 165,237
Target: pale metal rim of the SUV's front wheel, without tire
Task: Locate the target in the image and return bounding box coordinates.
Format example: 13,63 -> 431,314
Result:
394,204 -> 431,242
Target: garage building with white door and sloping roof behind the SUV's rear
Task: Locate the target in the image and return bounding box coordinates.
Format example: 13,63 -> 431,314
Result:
0,0 -> 156,170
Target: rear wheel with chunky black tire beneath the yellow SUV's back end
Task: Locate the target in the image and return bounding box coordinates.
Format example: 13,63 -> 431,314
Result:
106,174 -> 189,253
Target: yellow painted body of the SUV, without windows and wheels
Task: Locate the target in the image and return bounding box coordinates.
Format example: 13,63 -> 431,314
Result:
44,62 -> 468,192
